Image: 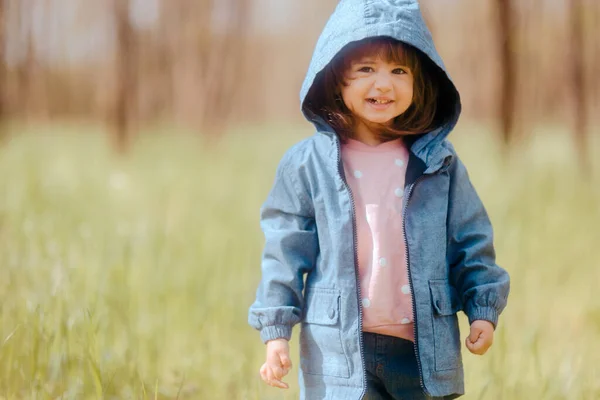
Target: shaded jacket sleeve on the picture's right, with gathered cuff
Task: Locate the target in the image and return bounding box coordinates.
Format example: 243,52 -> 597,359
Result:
447,156 -> 510,327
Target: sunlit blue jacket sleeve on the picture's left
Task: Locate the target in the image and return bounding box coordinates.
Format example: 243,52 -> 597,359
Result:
248,153 -> 318,343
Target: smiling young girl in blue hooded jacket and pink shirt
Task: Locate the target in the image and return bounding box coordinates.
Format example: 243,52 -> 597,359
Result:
249,0 -> 509,400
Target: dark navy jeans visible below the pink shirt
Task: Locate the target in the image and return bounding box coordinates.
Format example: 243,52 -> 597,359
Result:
363,332 -> 442,400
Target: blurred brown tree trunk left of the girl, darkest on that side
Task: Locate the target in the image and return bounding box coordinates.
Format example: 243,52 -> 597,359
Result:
112,0 -> 137,153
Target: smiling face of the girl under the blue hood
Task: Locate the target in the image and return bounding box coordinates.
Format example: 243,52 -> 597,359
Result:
341,56 -> 414,136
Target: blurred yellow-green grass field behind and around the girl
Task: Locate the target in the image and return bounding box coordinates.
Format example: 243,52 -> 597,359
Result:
0,126 -> 600,400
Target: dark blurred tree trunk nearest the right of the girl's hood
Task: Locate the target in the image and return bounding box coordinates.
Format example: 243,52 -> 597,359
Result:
496,0 -> 517,146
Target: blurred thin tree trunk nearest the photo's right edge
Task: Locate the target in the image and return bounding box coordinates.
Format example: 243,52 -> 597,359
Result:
570,0 -> 590,172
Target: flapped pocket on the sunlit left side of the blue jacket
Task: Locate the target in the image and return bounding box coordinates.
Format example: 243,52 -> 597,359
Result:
300,287 -> 350,378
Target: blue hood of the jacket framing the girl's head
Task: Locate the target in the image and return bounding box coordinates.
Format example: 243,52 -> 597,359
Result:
300,0 -> 461,158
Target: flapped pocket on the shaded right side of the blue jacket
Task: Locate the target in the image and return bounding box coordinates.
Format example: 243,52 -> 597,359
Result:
429,279 -> 462,371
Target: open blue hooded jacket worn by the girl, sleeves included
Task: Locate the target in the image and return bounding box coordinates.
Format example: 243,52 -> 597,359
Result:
249,0 -> 509,400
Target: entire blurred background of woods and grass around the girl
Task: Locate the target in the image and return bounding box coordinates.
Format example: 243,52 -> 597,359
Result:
0,0 -> 600,399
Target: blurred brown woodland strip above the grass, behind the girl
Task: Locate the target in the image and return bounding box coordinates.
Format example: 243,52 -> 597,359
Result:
1,0 -> 600,144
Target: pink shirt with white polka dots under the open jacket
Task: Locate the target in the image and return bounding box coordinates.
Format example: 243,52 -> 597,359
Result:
342,138 -> 414,341
